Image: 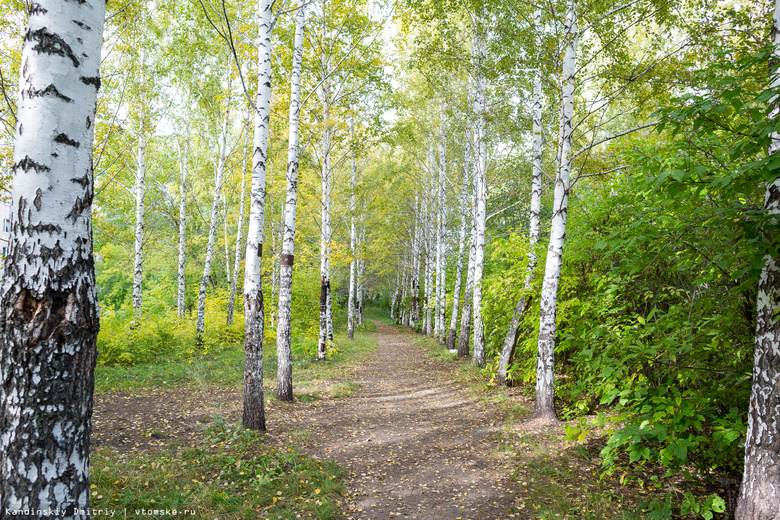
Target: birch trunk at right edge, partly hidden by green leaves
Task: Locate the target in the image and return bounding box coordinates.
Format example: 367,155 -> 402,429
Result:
735,0 -> 780,520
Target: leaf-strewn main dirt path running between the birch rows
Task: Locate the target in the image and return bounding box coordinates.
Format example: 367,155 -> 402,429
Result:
269,323 -> 518,520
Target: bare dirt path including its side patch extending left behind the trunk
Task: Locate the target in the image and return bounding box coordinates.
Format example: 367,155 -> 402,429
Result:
92,323 -> 522,520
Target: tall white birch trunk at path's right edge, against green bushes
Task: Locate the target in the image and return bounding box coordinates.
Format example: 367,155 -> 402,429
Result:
532,0 -> 577,420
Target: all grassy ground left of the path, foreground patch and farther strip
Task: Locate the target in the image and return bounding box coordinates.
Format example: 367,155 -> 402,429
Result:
91,324 -> 376,520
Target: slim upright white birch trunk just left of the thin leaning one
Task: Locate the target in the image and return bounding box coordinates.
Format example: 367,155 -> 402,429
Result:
472,20 -> 487,366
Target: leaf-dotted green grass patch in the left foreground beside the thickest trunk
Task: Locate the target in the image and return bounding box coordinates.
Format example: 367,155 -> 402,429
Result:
91,420 -> 346,520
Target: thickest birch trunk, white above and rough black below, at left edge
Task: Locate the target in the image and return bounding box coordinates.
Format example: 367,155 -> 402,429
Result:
0,0 -> 105,520
